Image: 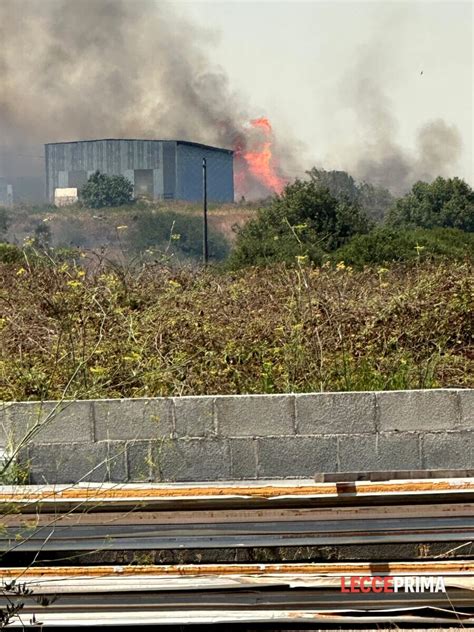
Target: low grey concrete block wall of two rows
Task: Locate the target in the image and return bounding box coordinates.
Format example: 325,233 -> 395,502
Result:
0,389 -> 474,483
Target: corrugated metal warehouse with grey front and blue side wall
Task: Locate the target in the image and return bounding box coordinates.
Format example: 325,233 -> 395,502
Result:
45,139 -> 234,202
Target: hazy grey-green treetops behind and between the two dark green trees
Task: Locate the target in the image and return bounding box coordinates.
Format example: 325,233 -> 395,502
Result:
307,167 -> 394,222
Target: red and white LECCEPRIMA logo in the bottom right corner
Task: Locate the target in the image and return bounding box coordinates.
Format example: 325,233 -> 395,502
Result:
341,575 -> 446,593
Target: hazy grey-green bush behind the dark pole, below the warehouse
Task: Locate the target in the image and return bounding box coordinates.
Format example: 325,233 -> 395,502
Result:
128,211 -> 229,261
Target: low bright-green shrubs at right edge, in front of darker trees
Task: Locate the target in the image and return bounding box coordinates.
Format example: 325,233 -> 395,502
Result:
331,228 -> 474,267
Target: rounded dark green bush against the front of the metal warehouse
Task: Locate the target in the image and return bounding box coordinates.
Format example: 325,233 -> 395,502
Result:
79,171 -> 133,208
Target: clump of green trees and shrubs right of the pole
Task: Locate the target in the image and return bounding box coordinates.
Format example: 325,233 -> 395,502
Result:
230,169 -> 474,267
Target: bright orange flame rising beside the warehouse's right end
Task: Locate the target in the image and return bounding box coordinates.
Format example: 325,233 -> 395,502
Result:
243,117 -> 286,193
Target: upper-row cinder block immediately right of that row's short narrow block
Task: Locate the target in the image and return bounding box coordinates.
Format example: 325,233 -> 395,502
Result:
215,395 -> 295,437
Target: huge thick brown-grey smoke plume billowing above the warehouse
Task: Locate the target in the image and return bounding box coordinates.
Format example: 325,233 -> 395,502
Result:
0,0 -> 291,196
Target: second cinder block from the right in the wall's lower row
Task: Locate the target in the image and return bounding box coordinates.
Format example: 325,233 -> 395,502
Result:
339,432 -> 422,472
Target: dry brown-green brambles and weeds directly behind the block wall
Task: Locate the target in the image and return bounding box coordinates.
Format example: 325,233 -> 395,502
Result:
0,248 -> 474,401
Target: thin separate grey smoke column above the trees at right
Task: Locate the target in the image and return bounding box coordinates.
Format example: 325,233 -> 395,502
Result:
340,40 -> 462,194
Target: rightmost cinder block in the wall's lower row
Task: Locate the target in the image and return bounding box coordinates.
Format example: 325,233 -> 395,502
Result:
422,431 -> 474,470
